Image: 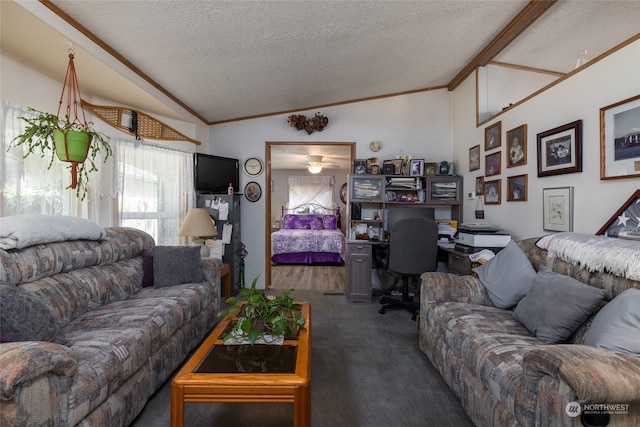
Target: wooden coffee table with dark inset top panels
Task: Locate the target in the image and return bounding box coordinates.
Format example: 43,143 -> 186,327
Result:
171,303 -> 311,427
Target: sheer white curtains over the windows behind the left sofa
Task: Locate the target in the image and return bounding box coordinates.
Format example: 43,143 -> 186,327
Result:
0,101 -> 195,245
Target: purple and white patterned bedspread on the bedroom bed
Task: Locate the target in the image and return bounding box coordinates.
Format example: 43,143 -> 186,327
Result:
271,229 -> 346,264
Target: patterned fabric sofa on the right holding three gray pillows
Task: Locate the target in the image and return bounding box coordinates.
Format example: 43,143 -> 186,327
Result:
419,238 -> 640,426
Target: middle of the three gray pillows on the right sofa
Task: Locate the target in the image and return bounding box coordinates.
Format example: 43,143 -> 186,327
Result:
513,266 -> 605,344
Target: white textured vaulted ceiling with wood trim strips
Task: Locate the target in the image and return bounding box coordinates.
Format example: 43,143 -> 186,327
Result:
0,0 -> 640,127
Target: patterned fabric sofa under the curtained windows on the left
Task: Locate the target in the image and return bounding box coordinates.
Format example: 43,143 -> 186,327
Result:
0,227 -> 221,426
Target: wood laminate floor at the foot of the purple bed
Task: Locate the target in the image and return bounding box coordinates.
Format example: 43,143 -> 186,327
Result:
271,265 -> 346,291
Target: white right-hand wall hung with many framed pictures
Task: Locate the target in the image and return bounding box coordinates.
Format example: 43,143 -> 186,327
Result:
452,41 -> 640,239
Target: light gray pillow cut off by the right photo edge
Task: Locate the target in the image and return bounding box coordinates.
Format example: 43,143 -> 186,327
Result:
584,288 -> 640,356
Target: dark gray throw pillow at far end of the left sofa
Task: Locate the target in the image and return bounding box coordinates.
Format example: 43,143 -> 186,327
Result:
153,246 -> 204,288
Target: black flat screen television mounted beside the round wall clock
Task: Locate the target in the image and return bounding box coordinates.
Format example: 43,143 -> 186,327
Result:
193,153 -> 240,194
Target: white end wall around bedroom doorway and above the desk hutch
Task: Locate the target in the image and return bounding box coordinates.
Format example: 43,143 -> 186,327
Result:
208,89 -> 452,286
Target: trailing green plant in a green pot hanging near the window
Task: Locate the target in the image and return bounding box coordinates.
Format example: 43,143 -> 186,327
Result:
9,107 -> 113,200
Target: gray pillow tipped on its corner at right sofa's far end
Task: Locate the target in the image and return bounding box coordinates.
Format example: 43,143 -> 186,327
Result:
473,240 -> 536,308
